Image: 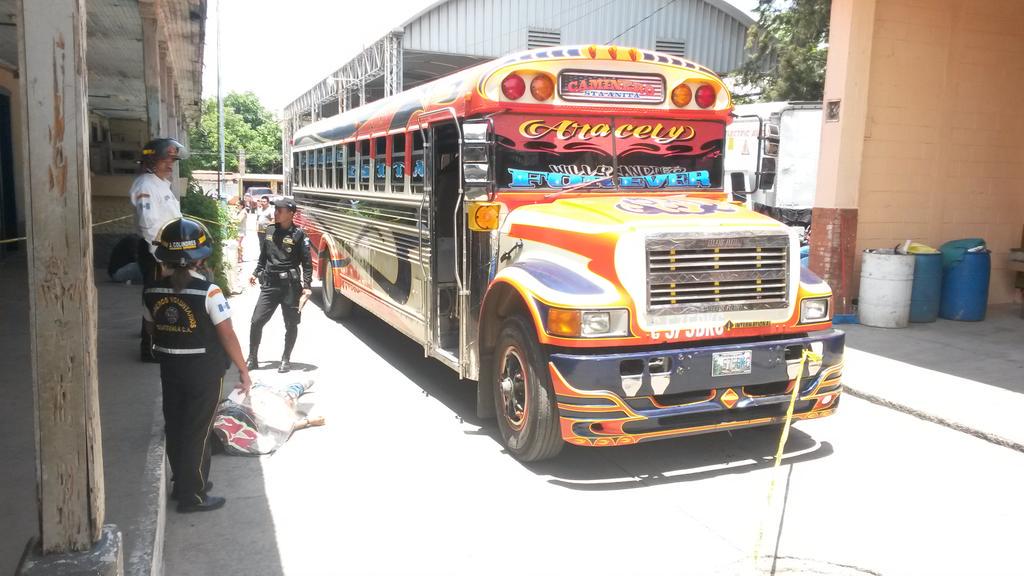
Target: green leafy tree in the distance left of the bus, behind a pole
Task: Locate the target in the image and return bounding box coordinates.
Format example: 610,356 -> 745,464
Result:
188,92 -> 281,174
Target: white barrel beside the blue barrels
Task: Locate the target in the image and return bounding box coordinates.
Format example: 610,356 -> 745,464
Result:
857,250 -> 914,328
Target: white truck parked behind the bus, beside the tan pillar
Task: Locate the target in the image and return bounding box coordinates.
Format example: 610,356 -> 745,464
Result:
725,101 -> 821,232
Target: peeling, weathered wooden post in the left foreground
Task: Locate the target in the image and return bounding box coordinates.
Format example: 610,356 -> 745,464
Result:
17,0 -> 104,554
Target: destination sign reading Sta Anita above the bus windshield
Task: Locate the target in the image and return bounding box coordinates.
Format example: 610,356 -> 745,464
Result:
558,72 -> 665,104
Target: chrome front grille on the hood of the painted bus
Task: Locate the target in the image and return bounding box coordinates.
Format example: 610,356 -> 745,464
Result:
647,232 -> 790,316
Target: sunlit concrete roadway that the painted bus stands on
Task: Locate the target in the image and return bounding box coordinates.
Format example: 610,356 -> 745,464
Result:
164,274 -> 1024,576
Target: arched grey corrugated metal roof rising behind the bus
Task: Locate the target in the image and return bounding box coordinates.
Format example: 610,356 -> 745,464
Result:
286,0 -> 754,117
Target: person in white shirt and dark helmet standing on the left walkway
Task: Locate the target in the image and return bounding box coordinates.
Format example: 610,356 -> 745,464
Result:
128,138 -> 188,362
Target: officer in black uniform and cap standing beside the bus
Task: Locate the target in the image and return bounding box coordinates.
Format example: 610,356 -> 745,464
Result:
249,198 -> 313,372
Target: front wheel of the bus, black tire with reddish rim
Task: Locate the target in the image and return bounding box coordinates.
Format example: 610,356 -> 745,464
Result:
489,316 -> 564,462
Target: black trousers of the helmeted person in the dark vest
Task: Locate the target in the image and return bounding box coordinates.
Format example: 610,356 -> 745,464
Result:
160,355 -> 225,503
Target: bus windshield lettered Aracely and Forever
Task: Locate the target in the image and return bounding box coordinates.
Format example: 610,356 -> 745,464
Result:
495,114 -> 725,192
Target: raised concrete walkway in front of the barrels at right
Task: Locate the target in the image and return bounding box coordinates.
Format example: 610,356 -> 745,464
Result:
841,304 -> 1024,452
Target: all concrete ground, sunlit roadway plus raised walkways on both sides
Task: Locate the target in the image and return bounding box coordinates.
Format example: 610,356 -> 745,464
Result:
0,217 -> 1024,575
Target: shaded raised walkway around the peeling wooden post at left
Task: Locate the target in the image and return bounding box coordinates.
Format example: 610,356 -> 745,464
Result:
0,253 -> 164,575
